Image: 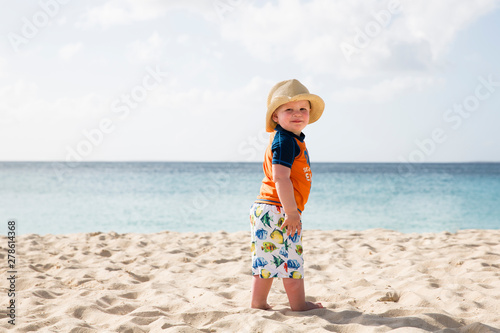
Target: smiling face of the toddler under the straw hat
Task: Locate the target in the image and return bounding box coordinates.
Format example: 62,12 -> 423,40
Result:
273,101 -> 311,135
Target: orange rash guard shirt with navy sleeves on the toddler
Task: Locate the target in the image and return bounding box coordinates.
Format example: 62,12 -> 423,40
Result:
255,125 -> 312,213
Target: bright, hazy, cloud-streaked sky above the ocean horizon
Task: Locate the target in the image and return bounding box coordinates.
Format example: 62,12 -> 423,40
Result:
0,0 -> 500,163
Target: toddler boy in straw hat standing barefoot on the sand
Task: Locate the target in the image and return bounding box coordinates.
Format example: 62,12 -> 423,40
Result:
250,80 -> 325,311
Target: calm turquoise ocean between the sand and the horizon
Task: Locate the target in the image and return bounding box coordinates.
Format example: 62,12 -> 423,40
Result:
0,162 -> 500,234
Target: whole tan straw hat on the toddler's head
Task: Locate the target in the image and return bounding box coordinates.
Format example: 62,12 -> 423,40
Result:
266,79 -> 325,132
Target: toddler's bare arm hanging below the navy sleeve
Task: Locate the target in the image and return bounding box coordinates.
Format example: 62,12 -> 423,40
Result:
273,164 -> 302,236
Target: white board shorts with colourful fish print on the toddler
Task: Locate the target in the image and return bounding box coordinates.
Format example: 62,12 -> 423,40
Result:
250,203 -> 304,279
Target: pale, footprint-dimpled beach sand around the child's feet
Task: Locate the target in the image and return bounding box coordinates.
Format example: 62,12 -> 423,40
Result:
0,229 -> 500,333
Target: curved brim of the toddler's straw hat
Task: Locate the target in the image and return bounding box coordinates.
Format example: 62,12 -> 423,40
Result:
266,94 -> 325,133
